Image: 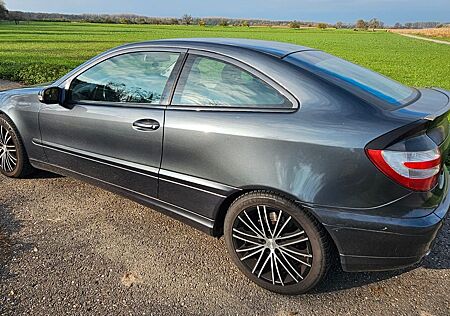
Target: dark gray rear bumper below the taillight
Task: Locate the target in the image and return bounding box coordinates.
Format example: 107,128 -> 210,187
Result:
312,171 -> 450,272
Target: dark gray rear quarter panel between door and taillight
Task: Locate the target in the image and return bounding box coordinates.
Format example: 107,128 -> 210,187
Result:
161,72 -> 416,218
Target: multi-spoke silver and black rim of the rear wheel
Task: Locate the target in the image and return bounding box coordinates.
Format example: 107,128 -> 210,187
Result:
233,205 -> 313,286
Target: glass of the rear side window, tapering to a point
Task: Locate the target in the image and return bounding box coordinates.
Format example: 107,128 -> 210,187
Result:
172,55 -> 292,108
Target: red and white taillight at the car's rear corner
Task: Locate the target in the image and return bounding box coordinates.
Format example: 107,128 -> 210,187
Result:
367,148 -> 441,191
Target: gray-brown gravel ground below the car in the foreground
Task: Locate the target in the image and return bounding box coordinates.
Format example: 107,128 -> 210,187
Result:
0,80 -> 450,316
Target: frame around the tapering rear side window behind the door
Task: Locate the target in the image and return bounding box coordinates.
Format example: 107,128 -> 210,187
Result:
167,49 -> 300,113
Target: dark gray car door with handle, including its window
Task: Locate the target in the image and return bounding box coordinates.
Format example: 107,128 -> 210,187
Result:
39,49 -> 183,197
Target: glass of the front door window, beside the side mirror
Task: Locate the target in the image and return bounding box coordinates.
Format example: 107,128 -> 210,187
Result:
70,52 -> 179,104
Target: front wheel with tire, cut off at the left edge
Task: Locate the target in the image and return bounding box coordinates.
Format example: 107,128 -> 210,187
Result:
0,114 -> 33,178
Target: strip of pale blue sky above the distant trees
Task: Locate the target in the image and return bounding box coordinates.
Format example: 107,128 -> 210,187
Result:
5,0 -> 450,24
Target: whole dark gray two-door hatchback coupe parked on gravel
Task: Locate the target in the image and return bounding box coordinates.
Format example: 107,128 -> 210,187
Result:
0,39 -> 450,294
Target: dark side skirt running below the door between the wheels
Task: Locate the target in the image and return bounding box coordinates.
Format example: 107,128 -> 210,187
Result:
30,159 -> 214,236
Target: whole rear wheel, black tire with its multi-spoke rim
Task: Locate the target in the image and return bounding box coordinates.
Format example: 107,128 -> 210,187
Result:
224,191 -> 332,295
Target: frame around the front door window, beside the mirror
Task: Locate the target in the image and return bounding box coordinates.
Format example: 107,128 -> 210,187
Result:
60,46 -> 187,109
